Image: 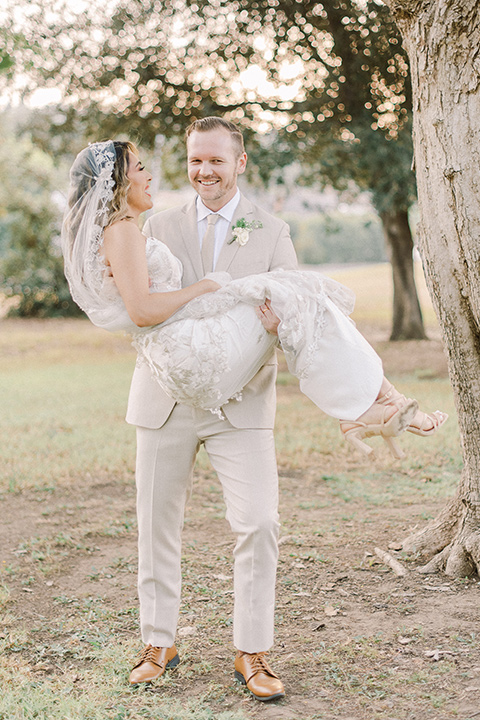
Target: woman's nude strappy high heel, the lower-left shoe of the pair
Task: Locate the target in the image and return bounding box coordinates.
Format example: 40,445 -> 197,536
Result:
340,396 -> 418,460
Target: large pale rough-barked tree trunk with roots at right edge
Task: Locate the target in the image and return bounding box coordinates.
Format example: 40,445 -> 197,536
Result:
386,0 -> 480,577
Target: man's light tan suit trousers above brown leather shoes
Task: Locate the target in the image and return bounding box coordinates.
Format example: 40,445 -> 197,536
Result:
136,405 -> 279,652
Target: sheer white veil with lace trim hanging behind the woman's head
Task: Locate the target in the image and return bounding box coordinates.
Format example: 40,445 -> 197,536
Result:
62,140 -> 132,330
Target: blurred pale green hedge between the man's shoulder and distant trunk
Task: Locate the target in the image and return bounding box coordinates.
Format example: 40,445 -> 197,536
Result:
283,213 -> 386,265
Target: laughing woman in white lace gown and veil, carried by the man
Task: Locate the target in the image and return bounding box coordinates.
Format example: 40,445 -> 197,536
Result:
62,141 -> 447,457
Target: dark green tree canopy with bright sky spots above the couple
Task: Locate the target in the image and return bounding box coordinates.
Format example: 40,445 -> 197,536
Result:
5,0 -> 415,212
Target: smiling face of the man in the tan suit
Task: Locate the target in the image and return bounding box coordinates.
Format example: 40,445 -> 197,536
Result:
187,128 -> 247,212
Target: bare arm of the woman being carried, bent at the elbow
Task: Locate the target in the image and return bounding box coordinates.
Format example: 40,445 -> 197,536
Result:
103,220 -> 220,327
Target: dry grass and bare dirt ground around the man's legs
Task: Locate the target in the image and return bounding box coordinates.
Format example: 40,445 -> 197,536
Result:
0,265 -> 480,720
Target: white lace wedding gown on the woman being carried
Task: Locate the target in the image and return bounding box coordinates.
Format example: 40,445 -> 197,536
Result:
94,238 -> 383,419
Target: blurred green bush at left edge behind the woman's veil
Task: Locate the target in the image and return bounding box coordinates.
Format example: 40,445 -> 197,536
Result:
0,124 -> 80,317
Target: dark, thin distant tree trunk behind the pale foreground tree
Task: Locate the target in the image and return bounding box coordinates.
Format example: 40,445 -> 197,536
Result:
380,210 -> 427,340
